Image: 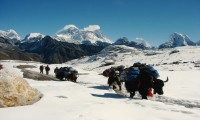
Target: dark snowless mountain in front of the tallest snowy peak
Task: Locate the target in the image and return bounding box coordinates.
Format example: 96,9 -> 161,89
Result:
19,36 -> 104,63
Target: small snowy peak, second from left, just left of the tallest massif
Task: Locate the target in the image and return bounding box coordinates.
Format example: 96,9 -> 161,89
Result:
22,33 -> 44,43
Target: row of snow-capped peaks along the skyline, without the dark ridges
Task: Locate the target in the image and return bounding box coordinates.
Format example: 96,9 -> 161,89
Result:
0,25 -> 200,49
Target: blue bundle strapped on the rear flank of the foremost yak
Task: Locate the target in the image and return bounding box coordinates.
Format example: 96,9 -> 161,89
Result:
127,67 -> 140,81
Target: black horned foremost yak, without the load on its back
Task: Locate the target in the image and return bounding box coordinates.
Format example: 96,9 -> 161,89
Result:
125,71 -> 168,99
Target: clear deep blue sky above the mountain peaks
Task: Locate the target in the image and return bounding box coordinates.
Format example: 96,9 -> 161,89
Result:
0,0 -> 200,46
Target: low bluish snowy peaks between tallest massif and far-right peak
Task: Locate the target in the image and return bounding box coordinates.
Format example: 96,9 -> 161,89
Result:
113,37 -> 152,49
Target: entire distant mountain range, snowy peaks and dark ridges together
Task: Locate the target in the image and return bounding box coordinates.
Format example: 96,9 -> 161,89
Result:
0,25 -> 200,63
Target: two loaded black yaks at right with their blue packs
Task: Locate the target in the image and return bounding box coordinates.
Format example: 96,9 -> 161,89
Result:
103,62 -> 168,99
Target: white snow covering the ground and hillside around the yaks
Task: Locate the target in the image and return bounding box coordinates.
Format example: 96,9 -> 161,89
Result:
0,46 -> 200,120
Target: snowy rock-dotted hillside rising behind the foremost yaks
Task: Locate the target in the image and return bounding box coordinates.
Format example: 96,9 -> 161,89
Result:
66,45 -> 200,73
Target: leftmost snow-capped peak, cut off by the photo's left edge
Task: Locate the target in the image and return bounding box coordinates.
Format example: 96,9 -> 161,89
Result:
0,29 -> 21,43
